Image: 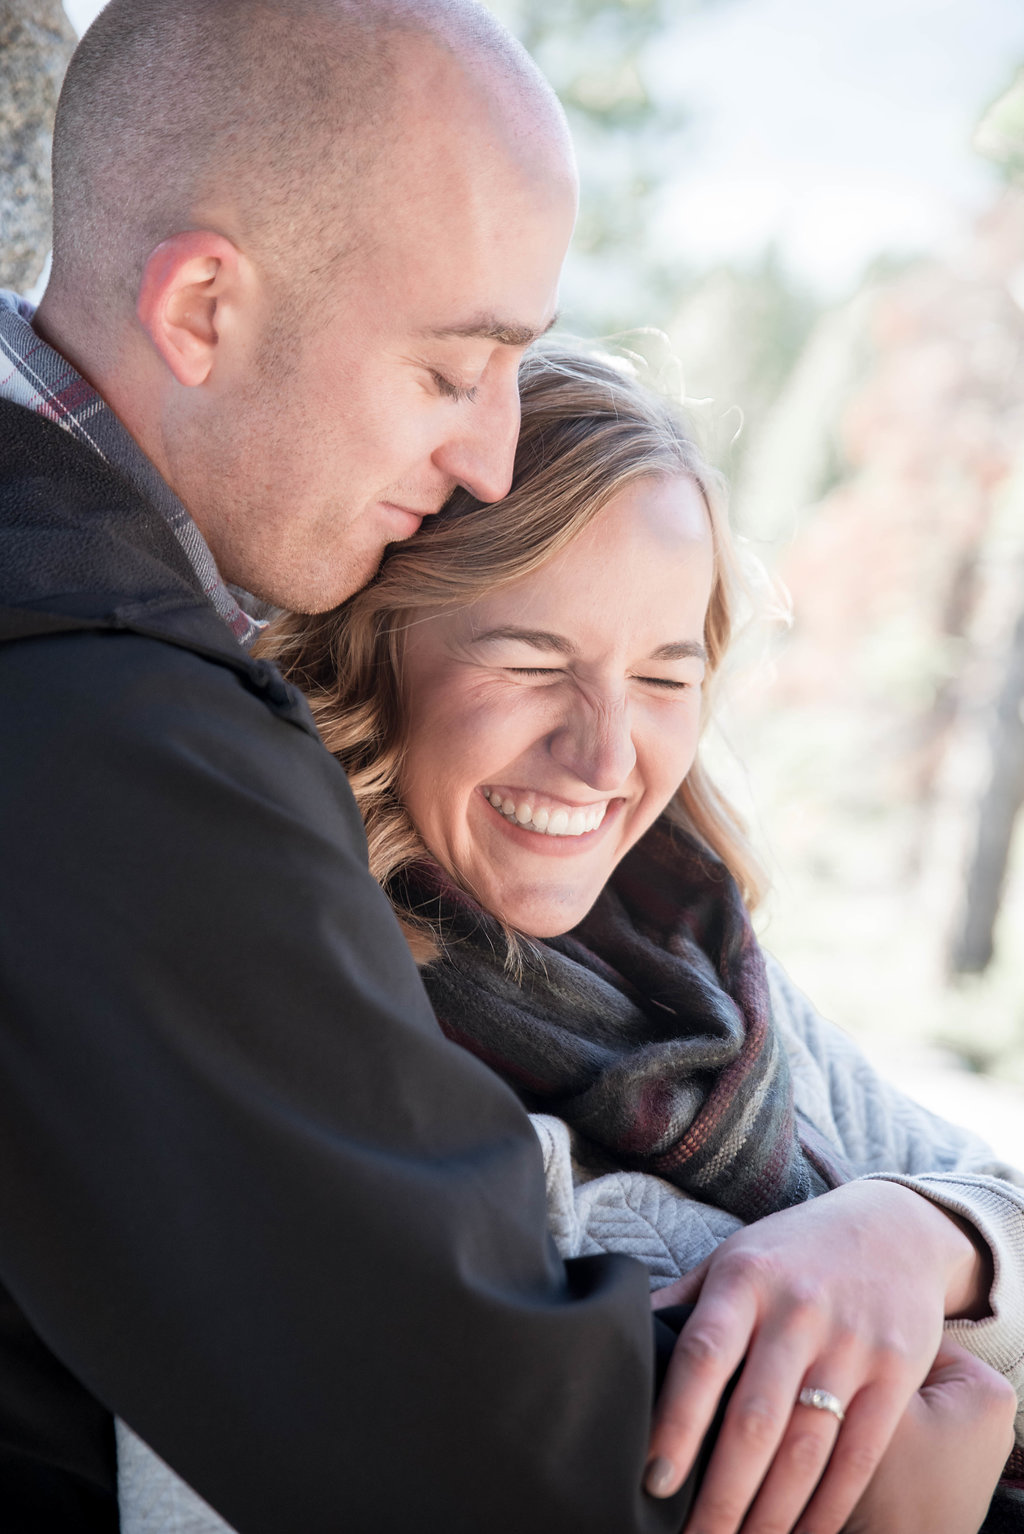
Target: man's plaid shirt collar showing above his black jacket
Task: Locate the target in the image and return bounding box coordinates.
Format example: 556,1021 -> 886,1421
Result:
0,290 -> 267,646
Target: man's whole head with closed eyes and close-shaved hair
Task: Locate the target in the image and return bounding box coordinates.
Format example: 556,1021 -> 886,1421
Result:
34,0 -> 576,612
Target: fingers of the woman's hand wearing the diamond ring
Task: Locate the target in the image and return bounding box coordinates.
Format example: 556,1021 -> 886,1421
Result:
648,1255 -> 926,1534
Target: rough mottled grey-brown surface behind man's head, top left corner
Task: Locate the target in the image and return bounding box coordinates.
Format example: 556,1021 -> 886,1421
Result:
0,0 -> 75,291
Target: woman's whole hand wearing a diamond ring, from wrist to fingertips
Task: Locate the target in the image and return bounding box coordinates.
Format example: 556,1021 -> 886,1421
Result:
647,1181 -> 990,1534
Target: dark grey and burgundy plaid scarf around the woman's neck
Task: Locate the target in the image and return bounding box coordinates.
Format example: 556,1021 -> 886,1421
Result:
394,821 -> 849,1221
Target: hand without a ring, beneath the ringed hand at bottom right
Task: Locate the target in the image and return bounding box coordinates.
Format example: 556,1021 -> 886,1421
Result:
843,1338 -> 1016,1534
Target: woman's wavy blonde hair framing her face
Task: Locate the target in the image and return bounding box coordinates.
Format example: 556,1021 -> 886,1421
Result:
259,344 -> 763,957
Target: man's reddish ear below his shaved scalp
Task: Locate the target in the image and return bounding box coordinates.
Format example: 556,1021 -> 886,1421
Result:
135,229 -> 244,388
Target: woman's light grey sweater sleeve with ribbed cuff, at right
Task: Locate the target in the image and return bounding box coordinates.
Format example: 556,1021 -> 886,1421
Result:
770,960 -> 1024,1442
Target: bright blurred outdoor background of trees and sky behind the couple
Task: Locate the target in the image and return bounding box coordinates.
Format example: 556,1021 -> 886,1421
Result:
16,0 -> 1024,1166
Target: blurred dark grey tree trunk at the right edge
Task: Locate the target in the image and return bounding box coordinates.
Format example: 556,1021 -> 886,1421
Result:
949,598 -> 1024,974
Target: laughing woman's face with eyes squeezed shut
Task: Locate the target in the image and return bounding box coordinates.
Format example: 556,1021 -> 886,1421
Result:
402,476 -> 713,937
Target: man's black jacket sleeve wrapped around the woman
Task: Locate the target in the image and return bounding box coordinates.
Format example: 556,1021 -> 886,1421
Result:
0,635 -> 692,1534
